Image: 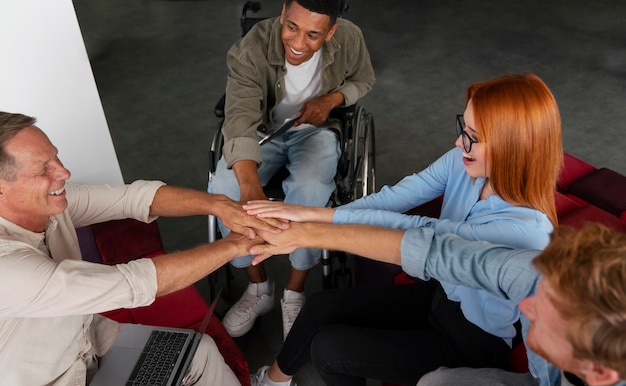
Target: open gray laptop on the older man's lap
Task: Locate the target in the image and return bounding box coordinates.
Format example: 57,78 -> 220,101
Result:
89,289 -> 221,386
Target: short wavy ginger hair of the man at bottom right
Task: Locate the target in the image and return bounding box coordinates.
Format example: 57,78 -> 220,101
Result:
534,224 -> 626,379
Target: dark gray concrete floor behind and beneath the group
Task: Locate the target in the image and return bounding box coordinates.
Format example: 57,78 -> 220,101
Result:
74,0 -> 626,386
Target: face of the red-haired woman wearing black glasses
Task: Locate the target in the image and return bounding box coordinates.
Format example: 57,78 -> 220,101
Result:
454,100 -> 490,178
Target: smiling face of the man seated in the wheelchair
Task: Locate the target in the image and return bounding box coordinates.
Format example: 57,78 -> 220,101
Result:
280,1 -> 337,66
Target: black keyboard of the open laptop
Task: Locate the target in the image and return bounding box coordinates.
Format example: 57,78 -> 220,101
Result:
126,330 -> 187,386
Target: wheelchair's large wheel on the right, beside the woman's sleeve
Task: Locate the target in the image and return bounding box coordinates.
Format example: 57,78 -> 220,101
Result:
349,106 -> 376,201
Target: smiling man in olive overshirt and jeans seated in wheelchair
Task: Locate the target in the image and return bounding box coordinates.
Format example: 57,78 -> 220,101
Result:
209,0 -> 375,338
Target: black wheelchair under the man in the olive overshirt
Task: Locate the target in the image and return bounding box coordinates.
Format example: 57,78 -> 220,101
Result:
208,1 -> 376,294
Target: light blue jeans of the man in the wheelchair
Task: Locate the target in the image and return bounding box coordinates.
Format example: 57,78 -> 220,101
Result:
208,127 -> 341,270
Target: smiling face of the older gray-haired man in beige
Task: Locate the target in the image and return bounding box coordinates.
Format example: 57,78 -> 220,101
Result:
0,126 -> 70,232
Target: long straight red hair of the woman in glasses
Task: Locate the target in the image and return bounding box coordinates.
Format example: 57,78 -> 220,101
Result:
466,74 -> 563,227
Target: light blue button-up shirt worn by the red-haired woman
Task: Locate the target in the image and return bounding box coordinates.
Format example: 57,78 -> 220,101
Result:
333,148 -> 553,345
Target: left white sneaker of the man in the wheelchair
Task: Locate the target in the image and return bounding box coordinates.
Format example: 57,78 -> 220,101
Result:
222,282 -> 274,338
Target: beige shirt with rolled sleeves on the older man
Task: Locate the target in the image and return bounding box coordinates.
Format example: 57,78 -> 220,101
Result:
0,181 -> 164,386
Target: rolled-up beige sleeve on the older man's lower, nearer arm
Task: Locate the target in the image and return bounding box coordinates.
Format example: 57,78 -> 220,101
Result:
0,248 -> 157,319
